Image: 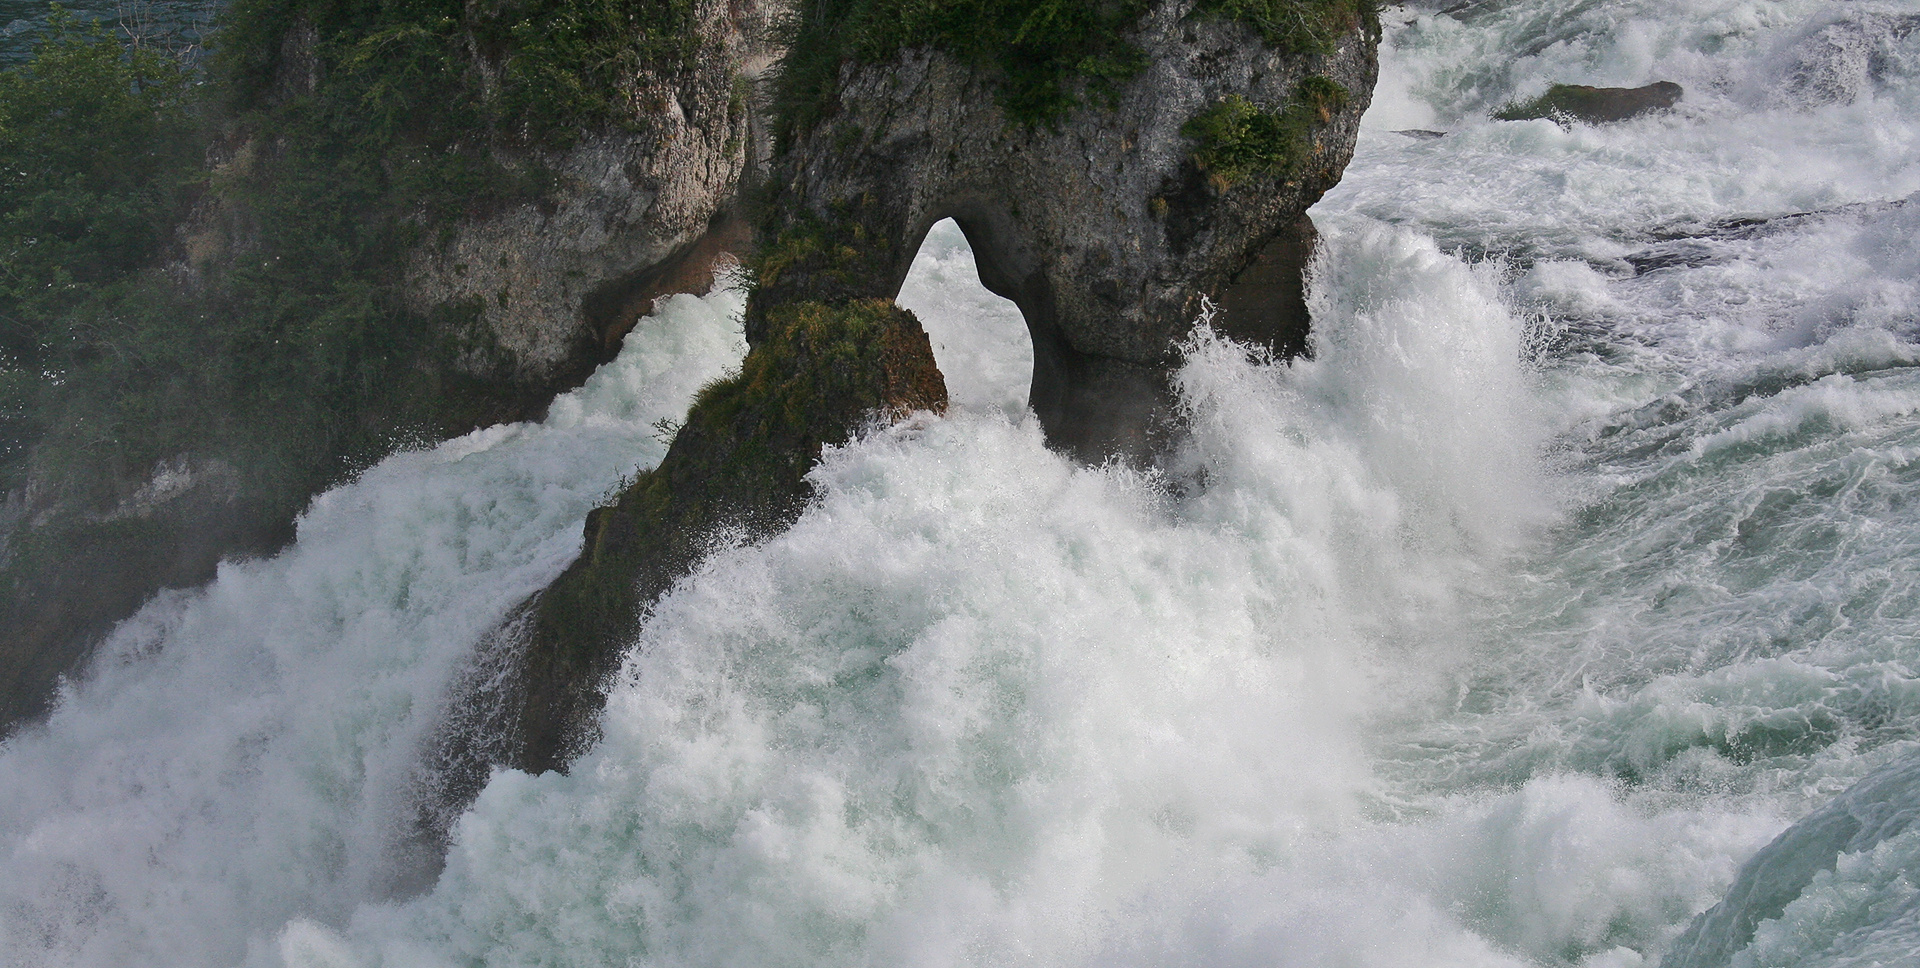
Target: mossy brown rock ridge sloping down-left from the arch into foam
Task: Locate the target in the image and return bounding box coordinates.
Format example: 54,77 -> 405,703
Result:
513,300 -> 947,770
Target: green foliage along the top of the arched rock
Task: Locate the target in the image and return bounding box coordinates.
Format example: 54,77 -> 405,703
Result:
776,0 -> 1150,144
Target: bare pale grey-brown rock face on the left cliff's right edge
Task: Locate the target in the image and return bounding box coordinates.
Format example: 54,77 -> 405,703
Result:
407,0 -> 783,396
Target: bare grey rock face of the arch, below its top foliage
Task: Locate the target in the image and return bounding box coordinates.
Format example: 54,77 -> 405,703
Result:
749,0 -> 1377,461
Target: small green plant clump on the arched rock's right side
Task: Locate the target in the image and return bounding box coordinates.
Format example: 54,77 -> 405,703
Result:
1181,75 -> 1348,188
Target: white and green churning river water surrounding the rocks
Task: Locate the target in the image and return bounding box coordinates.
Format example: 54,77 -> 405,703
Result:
0,0 -> 1920,968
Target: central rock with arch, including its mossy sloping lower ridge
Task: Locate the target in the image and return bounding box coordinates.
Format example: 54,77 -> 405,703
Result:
464,0 -> 1379,787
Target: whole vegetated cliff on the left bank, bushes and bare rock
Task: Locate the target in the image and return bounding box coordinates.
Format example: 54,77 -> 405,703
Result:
0,0 -> 780,732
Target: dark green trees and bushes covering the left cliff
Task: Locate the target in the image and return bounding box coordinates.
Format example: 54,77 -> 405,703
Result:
0,0 -> 714,513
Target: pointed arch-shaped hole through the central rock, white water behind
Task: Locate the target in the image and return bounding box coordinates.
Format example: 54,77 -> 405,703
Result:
897,219 -> 1033,413
